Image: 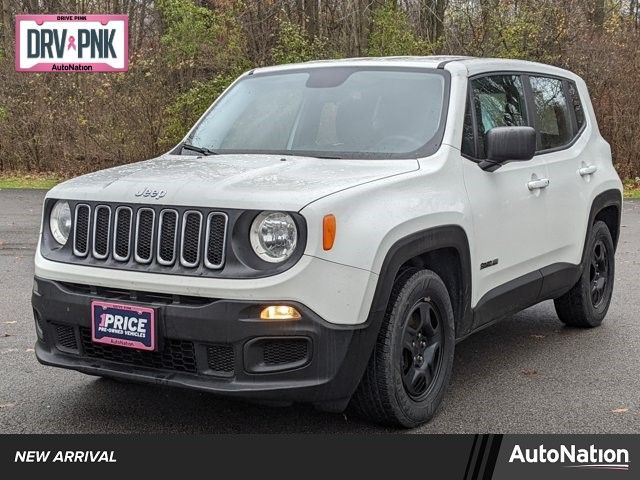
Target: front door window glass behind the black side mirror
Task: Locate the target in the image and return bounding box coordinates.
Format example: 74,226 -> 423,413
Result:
471,75 -> 527,158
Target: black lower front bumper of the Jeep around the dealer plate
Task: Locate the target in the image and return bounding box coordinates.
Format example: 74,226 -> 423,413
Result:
32,277 -> 375,410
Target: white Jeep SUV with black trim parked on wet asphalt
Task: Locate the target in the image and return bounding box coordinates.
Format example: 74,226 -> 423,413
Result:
32,57 -> 622,427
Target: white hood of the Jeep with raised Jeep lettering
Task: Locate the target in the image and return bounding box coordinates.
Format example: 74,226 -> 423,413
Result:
47,155 -> 419,211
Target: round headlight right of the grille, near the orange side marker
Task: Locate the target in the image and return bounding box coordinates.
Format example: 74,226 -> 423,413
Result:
249,212 -> 298,263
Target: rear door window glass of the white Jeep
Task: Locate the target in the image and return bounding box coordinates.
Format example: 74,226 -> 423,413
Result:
530,77 -> 584,151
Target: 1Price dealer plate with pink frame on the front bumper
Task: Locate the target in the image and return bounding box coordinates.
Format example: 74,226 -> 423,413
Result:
91,300 -> 157,351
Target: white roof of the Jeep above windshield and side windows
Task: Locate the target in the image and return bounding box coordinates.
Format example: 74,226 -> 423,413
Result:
256,55 -> 575,77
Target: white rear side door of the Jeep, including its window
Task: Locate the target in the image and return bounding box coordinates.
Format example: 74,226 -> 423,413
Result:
528,74 -> 598,266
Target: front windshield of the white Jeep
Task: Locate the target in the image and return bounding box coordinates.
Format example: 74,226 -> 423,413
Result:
185,67 -> 446,158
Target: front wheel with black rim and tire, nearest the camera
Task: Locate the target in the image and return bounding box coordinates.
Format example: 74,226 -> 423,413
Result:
351,269 -> 455,428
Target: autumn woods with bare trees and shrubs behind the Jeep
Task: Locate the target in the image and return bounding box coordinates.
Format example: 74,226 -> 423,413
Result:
0,0 -> 640,178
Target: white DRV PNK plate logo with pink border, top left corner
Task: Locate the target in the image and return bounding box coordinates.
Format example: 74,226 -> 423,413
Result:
16,15 -> 129,72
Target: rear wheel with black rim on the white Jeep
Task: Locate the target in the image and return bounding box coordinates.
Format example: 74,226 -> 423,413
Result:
554,221 -> 615,328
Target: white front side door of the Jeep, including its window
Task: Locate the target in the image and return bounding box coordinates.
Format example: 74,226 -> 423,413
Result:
461,74 -> 549,326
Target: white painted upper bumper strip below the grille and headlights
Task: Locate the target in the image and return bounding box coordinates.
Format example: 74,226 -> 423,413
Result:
35,248 -> 378,326
